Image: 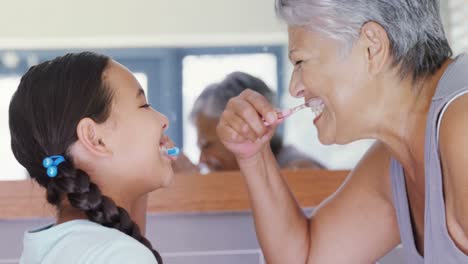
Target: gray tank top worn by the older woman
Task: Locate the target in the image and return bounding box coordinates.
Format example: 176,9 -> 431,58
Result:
390,55 -> 468,264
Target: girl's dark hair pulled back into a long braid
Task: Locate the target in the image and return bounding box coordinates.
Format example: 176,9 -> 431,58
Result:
9,52 -> 163,264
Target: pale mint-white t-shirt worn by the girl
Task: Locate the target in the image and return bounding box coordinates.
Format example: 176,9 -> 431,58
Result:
20,220 -> 158,264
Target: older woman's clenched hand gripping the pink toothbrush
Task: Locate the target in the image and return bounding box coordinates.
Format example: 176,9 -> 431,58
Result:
217,90 -> 279,161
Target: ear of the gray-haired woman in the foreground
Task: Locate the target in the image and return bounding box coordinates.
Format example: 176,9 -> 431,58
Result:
360,22 -> 390,75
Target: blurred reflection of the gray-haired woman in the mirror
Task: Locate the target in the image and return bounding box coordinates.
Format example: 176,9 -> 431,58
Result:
175,72 -> 323,171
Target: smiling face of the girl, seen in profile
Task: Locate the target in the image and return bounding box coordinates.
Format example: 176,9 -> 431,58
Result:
94,61 -> 173,194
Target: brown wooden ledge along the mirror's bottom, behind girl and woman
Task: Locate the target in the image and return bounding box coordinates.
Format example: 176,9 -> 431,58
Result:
0,170 -> 348,219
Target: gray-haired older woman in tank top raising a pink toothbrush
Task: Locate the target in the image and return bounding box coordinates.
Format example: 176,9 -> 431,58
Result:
217,0 -> 468,264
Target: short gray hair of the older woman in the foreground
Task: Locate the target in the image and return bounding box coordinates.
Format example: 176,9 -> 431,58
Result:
275,0 -> 452,80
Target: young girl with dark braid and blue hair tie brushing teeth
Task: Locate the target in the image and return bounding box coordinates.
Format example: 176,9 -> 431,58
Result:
9,52 -> 174,264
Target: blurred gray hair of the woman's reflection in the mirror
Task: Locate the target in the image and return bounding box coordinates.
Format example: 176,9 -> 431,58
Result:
190,72 -> 275,122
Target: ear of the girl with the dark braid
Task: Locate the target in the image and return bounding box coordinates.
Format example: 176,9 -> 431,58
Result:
76,117 -> 111,156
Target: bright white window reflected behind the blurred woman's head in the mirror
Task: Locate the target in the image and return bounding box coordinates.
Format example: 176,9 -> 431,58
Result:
182,53 -> 278,163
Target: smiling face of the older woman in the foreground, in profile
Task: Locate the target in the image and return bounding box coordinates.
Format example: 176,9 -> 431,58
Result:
288,26 -> 388,144
